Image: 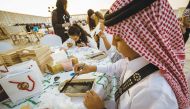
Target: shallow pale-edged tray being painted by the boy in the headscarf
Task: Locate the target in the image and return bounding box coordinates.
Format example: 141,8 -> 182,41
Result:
59,79 -> 94,97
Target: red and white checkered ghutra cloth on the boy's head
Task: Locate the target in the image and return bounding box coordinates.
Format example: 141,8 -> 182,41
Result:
106,0 -> 190,109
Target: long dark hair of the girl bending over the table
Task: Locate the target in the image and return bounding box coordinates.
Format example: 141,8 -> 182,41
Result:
68,24 -> 91,44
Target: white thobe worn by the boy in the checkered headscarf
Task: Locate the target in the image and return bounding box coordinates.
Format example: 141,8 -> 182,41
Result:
97,57 -> 178,109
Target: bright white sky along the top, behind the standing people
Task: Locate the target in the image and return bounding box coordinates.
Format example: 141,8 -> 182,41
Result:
0,0 -> 189,17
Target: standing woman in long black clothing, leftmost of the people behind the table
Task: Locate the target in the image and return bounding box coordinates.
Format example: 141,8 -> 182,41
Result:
52,0 -> 70,42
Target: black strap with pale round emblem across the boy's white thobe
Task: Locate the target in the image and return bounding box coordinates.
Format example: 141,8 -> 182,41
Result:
115,63 -> 159,101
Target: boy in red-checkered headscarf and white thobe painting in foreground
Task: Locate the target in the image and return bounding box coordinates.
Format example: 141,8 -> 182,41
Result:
74,0 -> 190,109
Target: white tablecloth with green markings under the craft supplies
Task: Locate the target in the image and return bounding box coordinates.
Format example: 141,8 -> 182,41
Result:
0,47 -> 119,109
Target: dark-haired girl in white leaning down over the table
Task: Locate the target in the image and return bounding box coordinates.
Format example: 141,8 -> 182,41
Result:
63,24 -> 97,49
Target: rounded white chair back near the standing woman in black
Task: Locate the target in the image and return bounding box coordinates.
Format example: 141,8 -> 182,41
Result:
40,34 -> 62,47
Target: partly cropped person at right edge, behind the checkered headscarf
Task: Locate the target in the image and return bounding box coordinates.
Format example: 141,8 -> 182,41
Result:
182,1 -> 190,43
